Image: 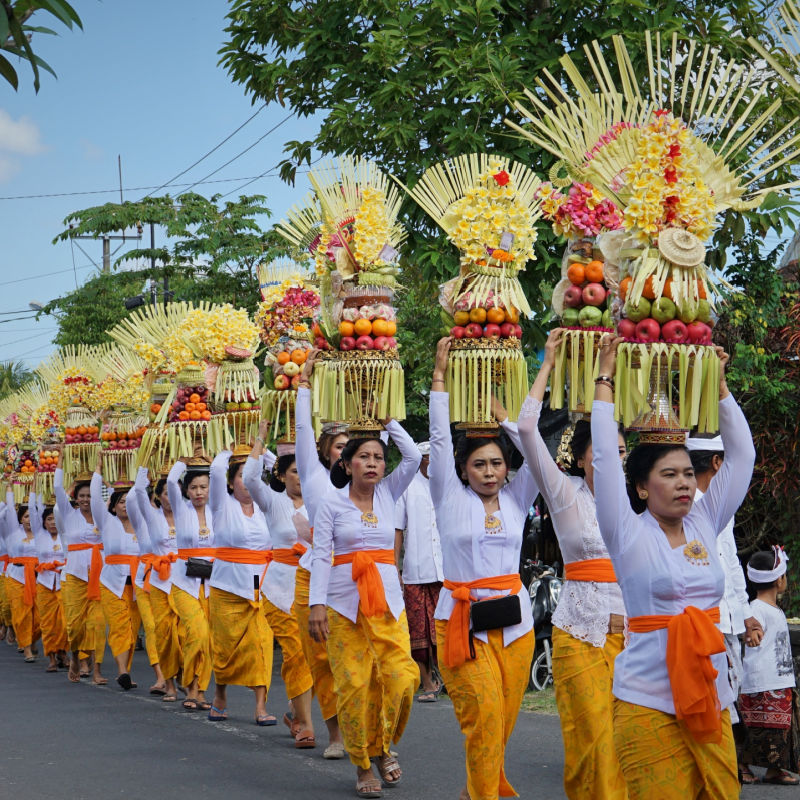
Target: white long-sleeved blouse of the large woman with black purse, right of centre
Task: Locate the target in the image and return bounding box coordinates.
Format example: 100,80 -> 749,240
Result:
428,392 -> 539,646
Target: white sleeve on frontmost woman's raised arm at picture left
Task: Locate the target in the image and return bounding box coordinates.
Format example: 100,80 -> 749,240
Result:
592,400 -> 637,556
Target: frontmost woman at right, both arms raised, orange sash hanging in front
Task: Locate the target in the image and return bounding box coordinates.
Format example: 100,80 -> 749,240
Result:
592,336 -> 755,800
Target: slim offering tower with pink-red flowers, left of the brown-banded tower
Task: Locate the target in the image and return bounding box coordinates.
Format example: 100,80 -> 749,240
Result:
256,258 -> 326,442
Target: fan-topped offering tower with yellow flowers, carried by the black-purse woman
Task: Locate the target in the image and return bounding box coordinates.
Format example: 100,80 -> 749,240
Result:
407,153 -> 541,434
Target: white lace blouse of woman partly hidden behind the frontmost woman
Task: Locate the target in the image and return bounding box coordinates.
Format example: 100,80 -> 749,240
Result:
518,397 -> 625,647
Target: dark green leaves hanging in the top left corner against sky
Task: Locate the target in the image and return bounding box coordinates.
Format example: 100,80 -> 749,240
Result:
0,0 -> 83,92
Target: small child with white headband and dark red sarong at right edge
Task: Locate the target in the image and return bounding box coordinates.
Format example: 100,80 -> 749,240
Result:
739,547 -> 800,786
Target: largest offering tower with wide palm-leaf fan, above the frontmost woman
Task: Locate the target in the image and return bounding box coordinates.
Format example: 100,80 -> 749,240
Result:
506,33 -> 800,441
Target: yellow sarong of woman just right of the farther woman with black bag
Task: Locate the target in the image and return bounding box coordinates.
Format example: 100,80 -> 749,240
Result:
208,586 -> 274,690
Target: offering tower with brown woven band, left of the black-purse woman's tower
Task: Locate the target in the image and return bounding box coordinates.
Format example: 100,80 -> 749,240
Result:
278,157 -> 406,436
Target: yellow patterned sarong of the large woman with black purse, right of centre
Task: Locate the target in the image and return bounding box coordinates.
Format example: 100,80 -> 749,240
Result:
436,619 -> 536,800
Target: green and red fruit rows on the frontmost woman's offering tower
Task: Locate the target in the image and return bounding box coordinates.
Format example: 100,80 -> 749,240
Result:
617,275 -> 714,345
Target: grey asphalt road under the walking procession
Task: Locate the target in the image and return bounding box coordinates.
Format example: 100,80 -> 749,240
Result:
0,643 -> 780,800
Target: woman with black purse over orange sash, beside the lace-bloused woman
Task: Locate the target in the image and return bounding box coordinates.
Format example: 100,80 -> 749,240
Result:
429,337 -> 538,800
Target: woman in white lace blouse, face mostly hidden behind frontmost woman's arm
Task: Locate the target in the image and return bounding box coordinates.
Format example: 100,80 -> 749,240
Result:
518,329 -> 626,800
